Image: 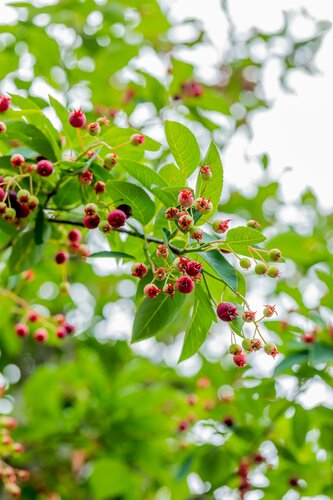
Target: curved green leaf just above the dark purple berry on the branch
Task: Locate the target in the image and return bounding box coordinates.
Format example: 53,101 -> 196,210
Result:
106,181 -> 155,225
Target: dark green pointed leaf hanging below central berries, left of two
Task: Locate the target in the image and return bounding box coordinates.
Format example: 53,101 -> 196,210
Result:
132,293 -> 185,343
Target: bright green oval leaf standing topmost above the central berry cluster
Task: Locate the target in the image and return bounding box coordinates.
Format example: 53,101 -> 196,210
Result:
165,120 -> 200,178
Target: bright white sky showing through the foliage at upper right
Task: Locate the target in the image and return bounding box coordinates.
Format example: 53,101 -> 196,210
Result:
167,0 -> 333,211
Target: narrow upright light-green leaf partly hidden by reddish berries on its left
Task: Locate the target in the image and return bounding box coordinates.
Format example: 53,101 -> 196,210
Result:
196,142 -> 223,217
